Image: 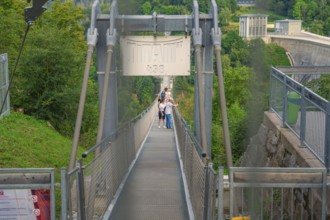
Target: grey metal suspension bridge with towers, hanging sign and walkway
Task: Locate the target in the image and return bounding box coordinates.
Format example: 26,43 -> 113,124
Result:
63,0 -> 232,219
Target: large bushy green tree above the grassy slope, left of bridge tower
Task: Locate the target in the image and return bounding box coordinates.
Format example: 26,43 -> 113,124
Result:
11,2 -> 97,143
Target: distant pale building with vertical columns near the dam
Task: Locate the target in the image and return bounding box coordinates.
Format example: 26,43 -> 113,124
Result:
239,14 -> 268,38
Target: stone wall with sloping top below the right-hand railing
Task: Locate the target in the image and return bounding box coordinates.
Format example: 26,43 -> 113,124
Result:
238,112 -> 330,219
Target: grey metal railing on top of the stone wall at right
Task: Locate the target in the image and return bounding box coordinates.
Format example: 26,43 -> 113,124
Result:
270,67 -> 330,170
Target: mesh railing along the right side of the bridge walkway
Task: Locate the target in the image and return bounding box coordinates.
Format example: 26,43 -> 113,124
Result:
173,108 -> 217,220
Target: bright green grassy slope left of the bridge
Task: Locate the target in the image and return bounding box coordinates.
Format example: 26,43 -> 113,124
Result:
0,112 -> 81,172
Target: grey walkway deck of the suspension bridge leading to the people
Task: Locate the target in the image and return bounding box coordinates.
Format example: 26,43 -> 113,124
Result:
109,118 -> 189,220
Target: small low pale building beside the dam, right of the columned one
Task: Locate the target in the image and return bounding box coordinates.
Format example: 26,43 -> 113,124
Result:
275,19 -> 301,35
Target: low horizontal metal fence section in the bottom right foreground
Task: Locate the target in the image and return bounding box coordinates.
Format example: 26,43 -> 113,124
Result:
229,167 -> 327,220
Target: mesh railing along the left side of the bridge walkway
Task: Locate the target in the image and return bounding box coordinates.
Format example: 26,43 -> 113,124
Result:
62,102 -> 158,220
